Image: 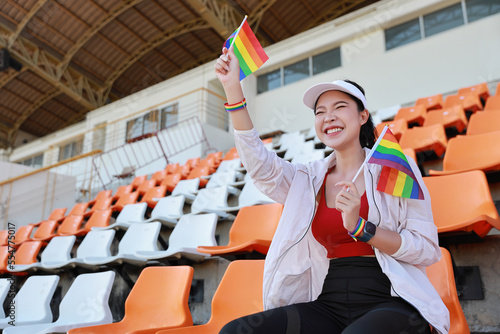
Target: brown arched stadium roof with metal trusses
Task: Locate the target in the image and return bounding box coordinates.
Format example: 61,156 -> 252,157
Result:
0,0 -> 377,148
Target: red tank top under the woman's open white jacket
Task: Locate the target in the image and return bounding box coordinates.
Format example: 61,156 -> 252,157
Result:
311,173 -> 375,259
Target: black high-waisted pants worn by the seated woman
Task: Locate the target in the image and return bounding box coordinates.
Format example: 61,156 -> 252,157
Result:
220,257 -> 430,334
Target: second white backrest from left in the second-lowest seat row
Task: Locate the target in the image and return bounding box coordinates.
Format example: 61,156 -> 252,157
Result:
76,229 -> 116,259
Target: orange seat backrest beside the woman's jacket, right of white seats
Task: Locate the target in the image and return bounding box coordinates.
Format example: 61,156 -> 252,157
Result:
229,203 -> 283,244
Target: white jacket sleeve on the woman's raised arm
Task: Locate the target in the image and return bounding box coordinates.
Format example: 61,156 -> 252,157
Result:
234,129 -> 296,204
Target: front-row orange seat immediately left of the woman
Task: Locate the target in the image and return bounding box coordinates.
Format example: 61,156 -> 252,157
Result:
151,260 -> 264,334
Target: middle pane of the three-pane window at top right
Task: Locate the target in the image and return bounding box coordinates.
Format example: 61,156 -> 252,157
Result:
424,3 -> 464,37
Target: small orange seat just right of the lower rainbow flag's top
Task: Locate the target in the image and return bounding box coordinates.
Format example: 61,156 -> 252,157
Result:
399,124 -> 448,157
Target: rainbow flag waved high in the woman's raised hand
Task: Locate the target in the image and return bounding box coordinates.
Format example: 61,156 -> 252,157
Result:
224,16 -> 269,81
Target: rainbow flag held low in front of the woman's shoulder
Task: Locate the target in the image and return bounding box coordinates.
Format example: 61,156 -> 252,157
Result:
367,126 -> 424,199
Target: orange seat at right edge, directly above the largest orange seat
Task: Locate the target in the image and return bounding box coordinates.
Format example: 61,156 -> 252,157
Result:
429,131 -> 500,175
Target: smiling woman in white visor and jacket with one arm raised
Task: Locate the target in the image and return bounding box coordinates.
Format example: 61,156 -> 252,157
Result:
215,48 -> 449,334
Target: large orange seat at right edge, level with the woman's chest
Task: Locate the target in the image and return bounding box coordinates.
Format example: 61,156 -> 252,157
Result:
424,171 -> 500,238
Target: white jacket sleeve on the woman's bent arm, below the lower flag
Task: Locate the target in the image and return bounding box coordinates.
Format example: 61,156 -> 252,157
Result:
392,158 -> 441,267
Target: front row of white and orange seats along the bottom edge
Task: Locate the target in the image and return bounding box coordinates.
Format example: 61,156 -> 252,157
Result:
0,248 -> 469,334
